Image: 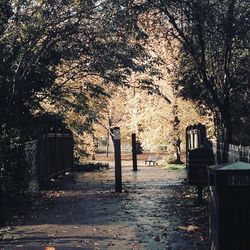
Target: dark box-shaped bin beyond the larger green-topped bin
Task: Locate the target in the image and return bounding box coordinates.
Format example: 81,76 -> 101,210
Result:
187,147 -> 215,186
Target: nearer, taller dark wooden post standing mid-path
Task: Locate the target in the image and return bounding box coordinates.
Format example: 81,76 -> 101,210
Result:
111,127 -> 122,193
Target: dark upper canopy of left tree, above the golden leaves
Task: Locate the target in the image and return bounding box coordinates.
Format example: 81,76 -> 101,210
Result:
0,0 -> 147,135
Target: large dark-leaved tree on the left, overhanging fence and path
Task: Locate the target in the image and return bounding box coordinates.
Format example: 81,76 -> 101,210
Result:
0,0 -> 151,212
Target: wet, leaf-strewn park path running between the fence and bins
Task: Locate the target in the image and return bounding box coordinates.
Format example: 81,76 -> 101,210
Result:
0,162 -> 208,250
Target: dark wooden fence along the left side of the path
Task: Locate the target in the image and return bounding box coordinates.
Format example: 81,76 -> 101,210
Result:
25,132 -> 74,191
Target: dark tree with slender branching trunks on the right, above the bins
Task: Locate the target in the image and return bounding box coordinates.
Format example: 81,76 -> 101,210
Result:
144,0 -> 250,143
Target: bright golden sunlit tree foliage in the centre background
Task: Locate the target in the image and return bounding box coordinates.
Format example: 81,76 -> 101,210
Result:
88,8 -> 213,162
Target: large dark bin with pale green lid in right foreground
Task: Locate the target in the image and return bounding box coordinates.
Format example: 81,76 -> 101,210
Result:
208,162 -> 250,250
